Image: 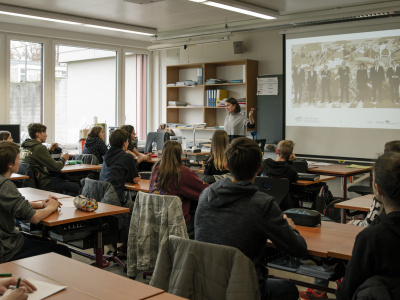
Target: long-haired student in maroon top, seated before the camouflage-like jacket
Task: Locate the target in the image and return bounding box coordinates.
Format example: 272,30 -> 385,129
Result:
150,141 -> 208,238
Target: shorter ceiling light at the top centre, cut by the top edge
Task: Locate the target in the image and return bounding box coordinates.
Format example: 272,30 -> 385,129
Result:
189,0 -> 279,20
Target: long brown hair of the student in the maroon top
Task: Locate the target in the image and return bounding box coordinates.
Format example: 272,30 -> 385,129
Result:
151,141 -> 182,192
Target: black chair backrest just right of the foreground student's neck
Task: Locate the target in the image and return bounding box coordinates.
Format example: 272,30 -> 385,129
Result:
254,176 -> 289,205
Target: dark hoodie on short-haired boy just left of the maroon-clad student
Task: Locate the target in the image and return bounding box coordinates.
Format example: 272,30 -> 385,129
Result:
100,146 -> 139,203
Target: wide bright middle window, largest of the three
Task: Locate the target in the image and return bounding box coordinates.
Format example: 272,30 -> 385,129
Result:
55,45 -> 117,144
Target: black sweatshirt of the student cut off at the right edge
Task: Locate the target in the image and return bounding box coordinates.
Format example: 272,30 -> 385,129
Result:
336,211 -> 400,300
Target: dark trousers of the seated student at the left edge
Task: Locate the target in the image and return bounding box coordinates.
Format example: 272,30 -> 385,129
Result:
11,236 -> 71,260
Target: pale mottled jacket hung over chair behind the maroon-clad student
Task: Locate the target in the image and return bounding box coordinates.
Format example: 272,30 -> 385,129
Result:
127,192 -> 188,277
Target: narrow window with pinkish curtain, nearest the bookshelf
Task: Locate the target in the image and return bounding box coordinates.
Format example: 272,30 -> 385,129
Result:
125,52 -> 148,140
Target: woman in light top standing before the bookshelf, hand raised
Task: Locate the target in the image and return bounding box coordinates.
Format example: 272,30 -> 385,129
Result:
224,98 -> 256,142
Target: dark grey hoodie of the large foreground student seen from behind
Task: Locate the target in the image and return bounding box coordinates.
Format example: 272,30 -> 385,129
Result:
194,178 -> 307,274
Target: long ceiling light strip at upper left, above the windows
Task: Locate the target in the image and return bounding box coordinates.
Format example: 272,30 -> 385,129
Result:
0,5 -> 157,36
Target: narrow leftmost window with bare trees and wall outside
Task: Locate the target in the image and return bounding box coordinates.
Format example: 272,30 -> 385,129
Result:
10,40 -> 43,140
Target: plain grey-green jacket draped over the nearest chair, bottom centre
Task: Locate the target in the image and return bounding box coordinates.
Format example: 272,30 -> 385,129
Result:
150,236 -> 260,300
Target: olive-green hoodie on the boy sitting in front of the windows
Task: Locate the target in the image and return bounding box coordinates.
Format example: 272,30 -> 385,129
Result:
20,139 -> 65,188
